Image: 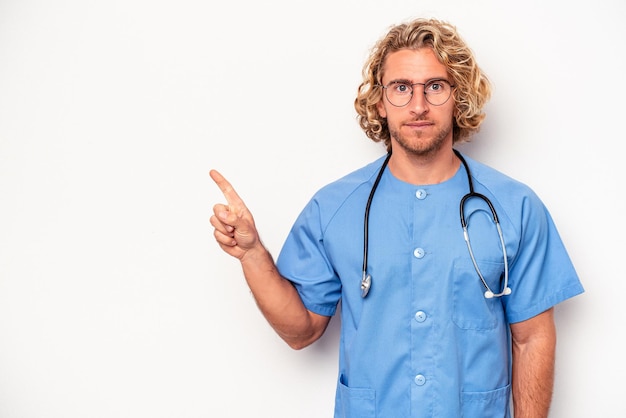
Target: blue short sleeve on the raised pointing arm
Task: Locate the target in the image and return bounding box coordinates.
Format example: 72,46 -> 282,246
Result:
277,199 -> 341,316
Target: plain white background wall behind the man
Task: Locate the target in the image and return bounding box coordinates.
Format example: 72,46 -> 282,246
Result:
0,0 -> 626,418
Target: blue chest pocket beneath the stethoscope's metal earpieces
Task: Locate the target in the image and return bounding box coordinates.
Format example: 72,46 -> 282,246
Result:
452,259 -> 504,330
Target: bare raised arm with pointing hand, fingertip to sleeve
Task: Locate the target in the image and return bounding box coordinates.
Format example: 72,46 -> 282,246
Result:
210,170 -> 330,349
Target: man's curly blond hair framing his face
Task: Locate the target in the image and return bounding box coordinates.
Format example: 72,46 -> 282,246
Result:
354,19 -> 491,150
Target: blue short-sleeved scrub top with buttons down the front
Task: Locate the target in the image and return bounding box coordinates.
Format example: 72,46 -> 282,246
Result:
277,152 -> 583,418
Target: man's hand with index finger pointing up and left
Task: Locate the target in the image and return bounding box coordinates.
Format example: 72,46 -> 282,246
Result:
209,170 -> 261,260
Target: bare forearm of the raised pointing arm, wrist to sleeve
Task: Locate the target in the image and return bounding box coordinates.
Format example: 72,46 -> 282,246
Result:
241,245 -> 328,349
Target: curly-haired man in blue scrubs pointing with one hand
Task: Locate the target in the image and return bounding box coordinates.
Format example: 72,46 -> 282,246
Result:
211,19 -> 583,418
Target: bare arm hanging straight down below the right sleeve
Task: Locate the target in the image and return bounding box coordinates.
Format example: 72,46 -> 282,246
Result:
511,308 -> 556,418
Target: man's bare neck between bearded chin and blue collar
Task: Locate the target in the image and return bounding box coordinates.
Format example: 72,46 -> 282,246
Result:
389,147 -> 461,186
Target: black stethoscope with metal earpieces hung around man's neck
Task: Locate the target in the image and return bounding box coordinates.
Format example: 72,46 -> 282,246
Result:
361,150 -> 511,299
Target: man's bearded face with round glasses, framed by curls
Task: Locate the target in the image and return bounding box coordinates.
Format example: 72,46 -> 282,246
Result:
377,48 -> 454,156
